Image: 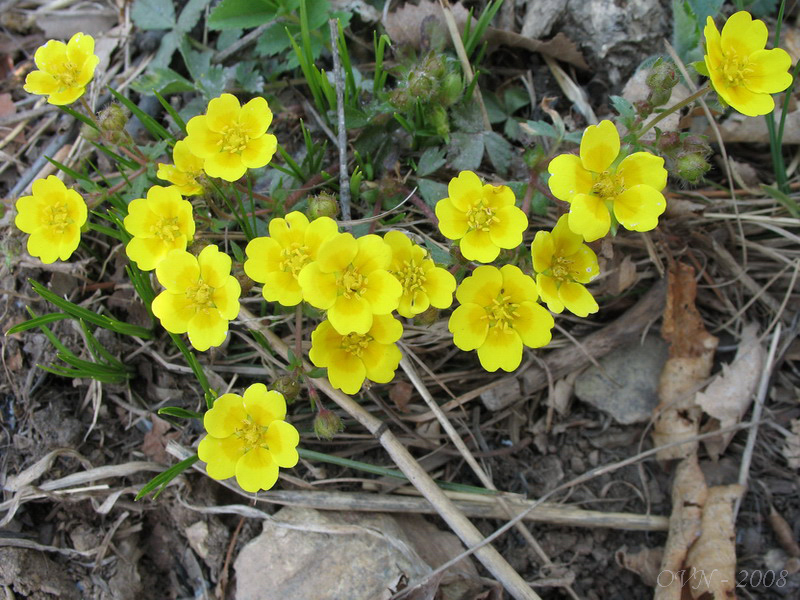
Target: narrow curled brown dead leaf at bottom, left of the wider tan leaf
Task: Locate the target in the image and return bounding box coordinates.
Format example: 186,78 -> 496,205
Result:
654,455 -> 708,600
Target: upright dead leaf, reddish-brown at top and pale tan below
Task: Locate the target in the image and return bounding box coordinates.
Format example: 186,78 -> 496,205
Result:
653,263 -> 718,460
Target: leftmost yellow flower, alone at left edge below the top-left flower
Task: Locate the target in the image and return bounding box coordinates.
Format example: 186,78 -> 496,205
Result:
14,175 -> 87,264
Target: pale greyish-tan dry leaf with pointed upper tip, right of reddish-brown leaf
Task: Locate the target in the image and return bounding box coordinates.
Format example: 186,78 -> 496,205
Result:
695,323 -> 766,460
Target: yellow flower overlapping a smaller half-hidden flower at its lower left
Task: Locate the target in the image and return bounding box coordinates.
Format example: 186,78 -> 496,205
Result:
186,94 -> 278,181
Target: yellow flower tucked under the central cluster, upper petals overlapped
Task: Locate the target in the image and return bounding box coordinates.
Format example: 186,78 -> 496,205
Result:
308,315 -> 403,394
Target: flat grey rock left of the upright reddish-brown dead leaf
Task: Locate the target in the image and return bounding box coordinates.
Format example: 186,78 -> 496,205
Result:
575,335 -> 668,424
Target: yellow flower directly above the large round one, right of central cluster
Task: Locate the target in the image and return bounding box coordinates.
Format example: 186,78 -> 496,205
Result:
436,171 -> 528,262
